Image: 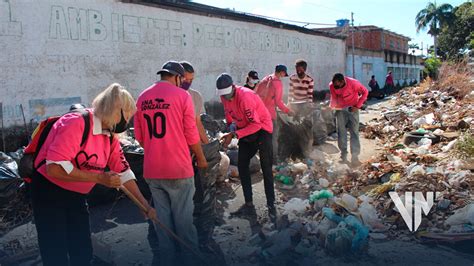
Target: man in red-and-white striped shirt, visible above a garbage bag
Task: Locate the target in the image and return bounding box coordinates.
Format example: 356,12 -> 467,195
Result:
289,59 -> 314,103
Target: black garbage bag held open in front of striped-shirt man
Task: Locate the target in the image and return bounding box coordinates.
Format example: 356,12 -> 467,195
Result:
278,105 -> 313,159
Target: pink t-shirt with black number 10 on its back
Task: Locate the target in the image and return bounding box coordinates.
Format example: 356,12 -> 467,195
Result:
135,81 -> 199,179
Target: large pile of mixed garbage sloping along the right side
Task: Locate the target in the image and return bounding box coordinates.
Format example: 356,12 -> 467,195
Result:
342,83 -> 474,237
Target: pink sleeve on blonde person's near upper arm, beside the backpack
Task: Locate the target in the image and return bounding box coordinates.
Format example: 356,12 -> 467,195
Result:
46,114 -> 83,162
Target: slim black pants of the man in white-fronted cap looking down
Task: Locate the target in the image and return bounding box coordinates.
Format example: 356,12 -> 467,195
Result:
238,130 -> 275,206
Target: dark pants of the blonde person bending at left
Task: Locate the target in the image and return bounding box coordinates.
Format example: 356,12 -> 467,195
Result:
31,174 -> 92,266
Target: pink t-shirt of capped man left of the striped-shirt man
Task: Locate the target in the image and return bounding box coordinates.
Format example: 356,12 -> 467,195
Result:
255,74 -> 290,119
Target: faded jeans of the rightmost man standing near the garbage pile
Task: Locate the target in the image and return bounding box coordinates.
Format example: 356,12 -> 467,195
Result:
336,110 -> 360,158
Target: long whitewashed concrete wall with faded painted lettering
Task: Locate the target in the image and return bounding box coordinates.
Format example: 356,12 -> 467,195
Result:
0,0 -> 345,126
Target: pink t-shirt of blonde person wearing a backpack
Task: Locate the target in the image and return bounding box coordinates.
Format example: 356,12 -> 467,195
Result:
35,110 -> 130,194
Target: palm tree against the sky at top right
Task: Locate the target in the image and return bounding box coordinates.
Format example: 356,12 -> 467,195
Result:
415,1 -> 453,56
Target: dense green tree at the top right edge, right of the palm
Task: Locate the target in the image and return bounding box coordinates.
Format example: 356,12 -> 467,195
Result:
438,2 -> 474,59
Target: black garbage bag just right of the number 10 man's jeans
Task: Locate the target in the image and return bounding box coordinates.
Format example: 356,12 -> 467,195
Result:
194,141 -> 221,245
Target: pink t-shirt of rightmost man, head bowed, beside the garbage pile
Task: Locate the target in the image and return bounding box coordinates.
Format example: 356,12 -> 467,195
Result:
329,77 -> 369,109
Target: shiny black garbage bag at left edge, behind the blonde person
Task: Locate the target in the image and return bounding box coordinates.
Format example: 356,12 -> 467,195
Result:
0,152 -> 23,205
